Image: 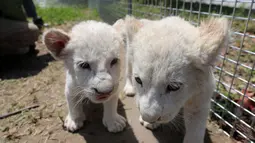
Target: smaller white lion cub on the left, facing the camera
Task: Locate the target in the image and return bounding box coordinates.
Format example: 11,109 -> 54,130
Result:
43,21 -> 126,132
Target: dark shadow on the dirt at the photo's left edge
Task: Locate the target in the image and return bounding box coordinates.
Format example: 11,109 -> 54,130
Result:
0,53 -> 53,80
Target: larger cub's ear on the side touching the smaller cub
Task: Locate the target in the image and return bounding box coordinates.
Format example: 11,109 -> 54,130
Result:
125,15 -> 144,41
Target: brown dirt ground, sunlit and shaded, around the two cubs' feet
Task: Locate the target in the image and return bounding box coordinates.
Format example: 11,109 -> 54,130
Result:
0,25 -> 235,143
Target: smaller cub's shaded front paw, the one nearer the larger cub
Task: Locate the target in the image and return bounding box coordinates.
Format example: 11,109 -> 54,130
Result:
103,114 -> 126,133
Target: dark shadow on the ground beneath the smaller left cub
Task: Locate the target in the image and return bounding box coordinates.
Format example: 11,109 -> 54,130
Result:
78,100 -> 138,143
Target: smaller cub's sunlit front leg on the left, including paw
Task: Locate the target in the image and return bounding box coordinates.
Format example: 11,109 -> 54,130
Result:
64,82 -> 86,132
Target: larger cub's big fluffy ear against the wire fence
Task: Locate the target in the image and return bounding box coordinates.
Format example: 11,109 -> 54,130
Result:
193,18 -> 230,66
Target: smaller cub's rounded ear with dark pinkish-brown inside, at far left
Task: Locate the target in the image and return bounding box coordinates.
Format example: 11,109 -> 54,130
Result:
43,29 -> 70,59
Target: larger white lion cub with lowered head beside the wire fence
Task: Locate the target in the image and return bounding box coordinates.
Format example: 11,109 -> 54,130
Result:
125,16 -> 229,143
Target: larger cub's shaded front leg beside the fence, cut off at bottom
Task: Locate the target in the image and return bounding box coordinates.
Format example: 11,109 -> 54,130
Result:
183,99 -> 210,143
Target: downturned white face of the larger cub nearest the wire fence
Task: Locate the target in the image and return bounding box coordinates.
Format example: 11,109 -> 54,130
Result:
132,43 -> 199,123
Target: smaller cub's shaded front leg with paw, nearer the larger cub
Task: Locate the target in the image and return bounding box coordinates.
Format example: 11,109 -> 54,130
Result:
103,95 -> 126,133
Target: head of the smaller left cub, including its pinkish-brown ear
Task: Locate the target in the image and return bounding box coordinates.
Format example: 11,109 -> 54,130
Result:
43,21 -> 124,103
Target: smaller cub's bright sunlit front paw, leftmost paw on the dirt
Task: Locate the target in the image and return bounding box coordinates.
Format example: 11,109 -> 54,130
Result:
64,115 -> 83,132
